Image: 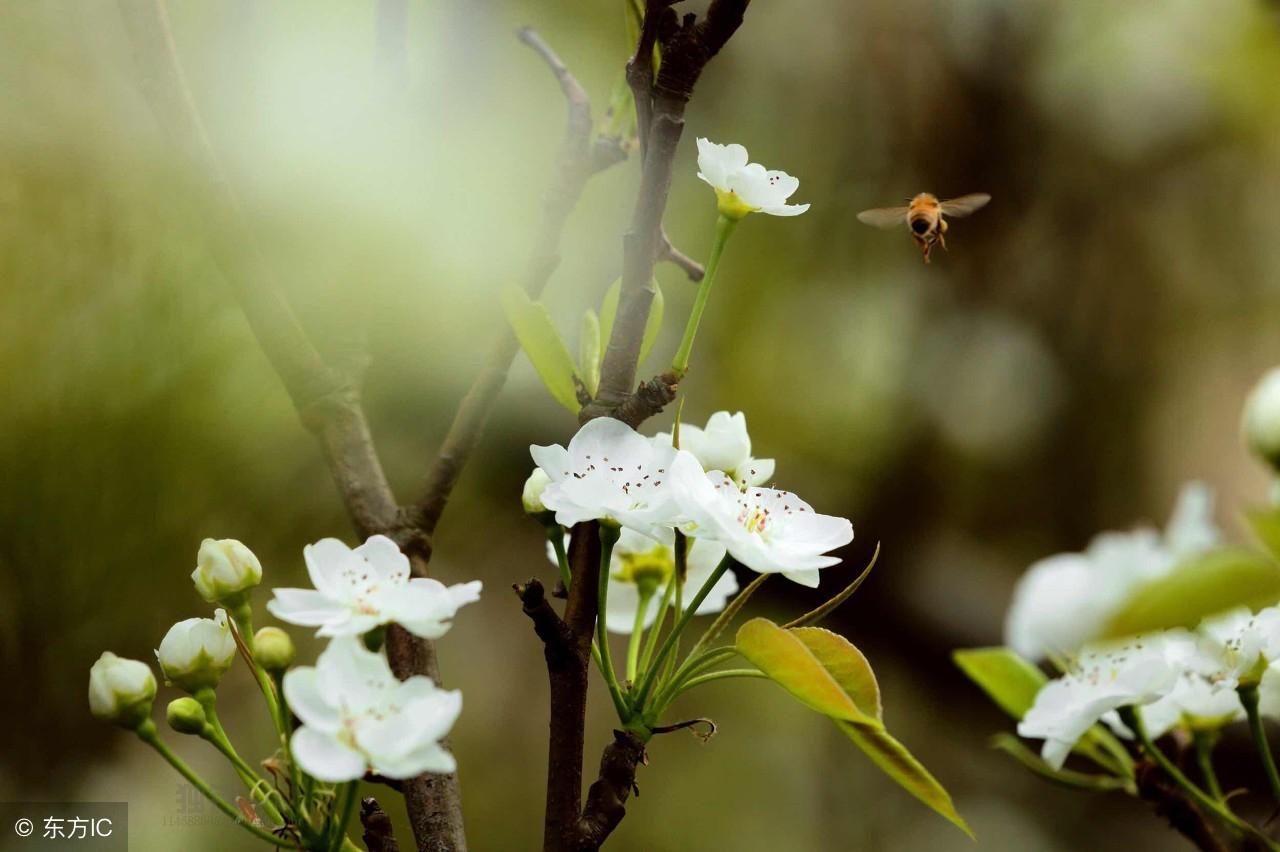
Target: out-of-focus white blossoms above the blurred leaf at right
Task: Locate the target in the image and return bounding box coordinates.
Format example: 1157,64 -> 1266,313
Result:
1005,482 -> 1220,660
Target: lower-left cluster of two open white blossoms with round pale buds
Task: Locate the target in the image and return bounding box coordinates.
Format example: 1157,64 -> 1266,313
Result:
88,536 -> 480,783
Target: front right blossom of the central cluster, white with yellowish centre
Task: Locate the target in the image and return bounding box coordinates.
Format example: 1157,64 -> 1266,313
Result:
669,450 -> 854,588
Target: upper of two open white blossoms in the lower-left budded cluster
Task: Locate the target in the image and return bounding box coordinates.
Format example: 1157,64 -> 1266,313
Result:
266,536 -> 481,638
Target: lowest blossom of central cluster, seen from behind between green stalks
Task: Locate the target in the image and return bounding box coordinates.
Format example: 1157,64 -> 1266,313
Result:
547,527 -> 737,633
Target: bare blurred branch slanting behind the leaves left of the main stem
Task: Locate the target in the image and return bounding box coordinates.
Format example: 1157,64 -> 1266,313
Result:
412,28 -> 626,536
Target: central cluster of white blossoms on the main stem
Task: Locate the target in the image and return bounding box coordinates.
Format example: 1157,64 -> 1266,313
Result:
524,412 -> 854,633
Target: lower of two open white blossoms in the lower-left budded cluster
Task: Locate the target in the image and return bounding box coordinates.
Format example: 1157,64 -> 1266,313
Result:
284,636 -> 462,783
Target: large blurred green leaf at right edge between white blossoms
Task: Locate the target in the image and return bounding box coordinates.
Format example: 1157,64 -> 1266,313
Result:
1103,549 -> 1280,638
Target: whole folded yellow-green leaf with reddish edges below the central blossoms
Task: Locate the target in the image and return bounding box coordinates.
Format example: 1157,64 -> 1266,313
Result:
736,618 -> 973,837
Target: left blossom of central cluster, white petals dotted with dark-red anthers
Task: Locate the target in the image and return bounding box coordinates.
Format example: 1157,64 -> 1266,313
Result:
529,417 -> 678,537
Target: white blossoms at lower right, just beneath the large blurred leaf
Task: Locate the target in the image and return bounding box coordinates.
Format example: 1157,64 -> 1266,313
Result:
1018,608 -> 1280,769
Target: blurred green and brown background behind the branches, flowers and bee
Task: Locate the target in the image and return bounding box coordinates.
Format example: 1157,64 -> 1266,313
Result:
0,0 -> 1280,852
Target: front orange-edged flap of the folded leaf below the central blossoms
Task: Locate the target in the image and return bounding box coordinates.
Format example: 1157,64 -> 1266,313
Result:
735,618 -> 882,728
